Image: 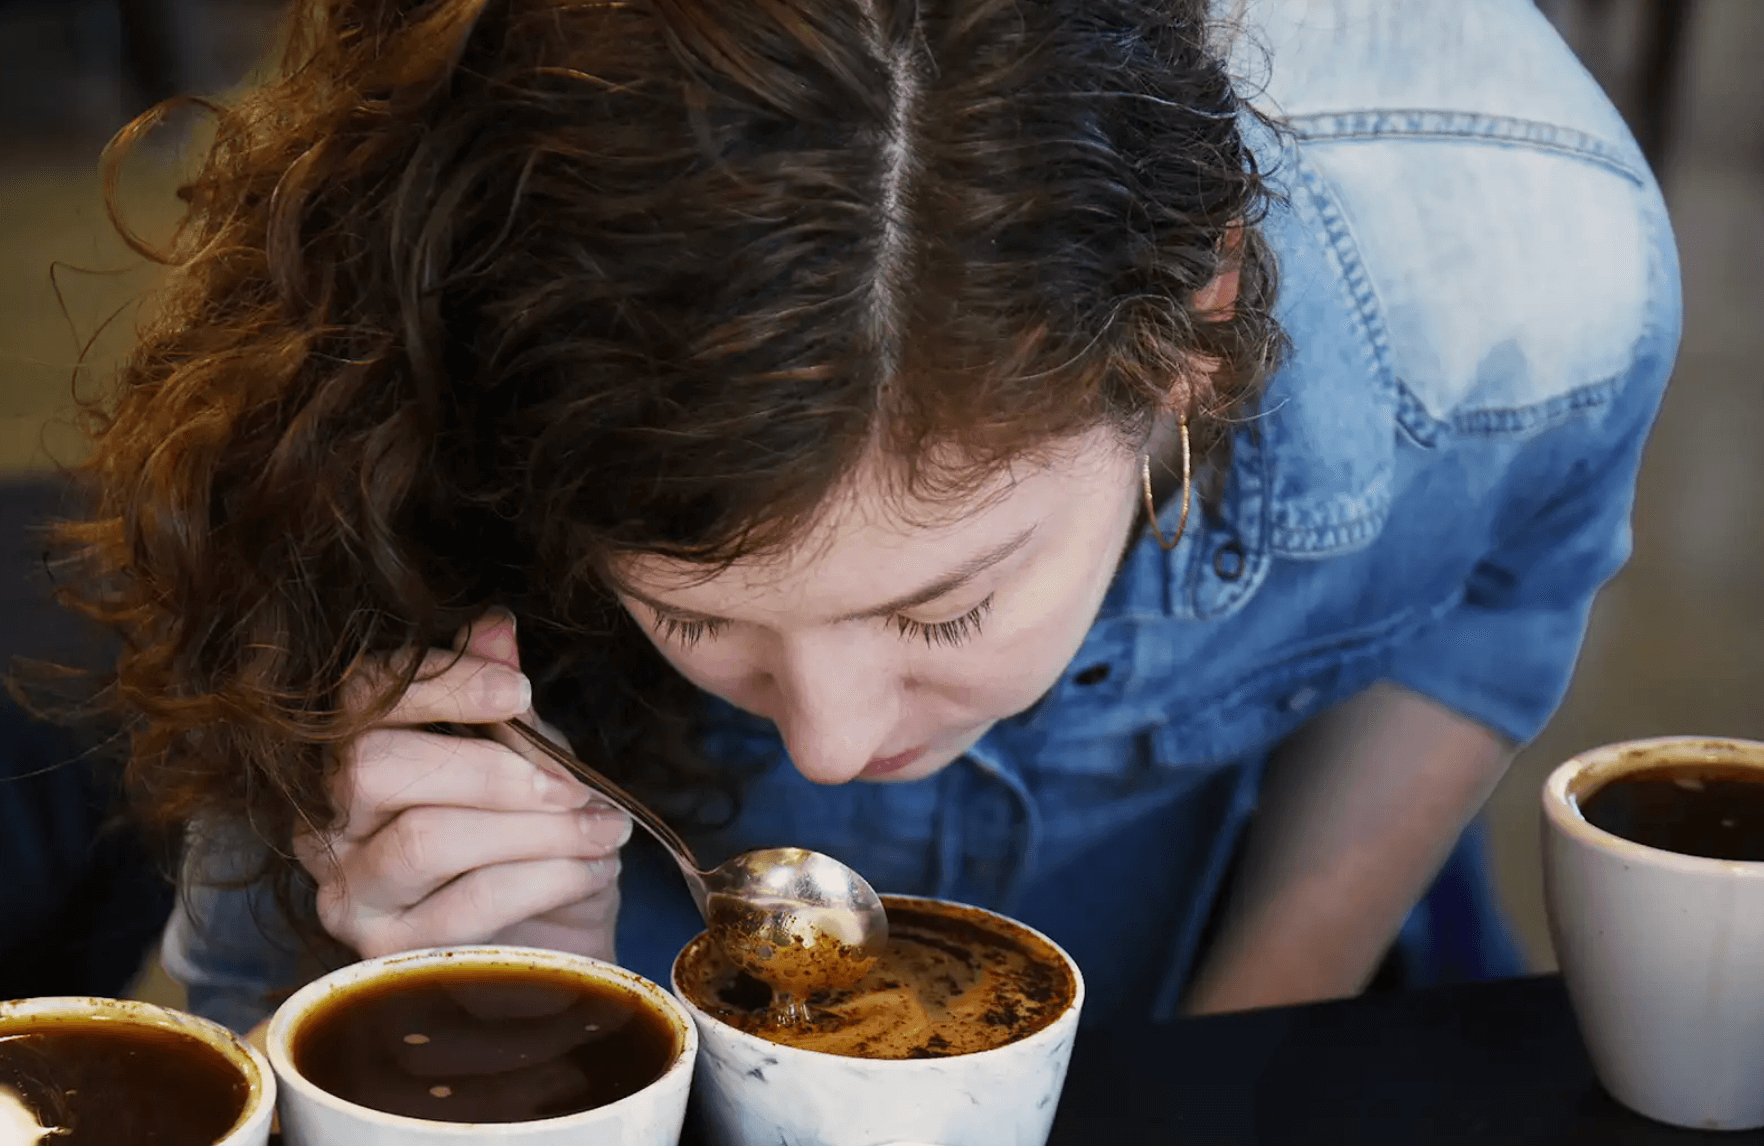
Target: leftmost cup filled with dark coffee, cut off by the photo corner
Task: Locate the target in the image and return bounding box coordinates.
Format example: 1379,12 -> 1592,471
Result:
0,998 -> 275,1146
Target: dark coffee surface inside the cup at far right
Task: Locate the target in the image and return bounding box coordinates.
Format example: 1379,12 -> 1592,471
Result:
1579,763 -> 1764,860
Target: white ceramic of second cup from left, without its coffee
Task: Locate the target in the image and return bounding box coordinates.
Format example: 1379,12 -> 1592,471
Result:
268,945 -> 699,1146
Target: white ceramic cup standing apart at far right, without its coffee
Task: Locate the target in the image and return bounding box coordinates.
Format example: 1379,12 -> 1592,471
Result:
1544,737 -> 1764,1130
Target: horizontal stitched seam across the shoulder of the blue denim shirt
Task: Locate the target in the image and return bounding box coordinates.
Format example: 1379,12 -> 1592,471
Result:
1286,108 -> 1648,185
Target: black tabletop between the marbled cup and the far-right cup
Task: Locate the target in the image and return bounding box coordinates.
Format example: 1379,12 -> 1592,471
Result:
1051,975 -> 1764,1146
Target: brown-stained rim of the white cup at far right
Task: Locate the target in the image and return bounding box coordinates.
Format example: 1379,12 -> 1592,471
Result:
1544,735 -> 1764,880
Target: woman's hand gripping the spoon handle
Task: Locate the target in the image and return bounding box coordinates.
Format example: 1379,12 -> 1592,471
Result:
295,612 -> 632,961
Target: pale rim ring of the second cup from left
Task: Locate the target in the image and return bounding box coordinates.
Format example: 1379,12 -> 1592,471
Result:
265,943 -> 699,1139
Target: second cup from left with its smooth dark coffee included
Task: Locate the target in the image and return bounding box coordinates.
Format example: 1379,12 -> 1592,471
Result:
268,947 -> 699,1146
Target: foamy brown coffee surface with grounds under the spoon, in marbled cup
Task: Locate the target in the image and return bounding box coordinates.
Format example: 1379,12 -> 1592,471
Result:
676,896 -> 1078,1058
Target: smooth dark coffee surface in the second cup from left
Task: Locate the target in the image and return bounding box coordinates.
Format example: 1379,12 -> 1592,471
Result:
293,966 -> 677,1123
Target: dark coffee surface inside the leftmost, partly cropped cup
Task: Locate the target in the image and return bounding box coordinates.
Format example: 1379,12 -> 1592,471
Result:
0,1019 -> 250,1146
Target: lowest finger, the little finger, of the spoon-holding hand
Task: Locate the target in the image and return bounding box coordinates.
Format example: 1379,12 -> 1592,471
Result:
349,859 -> 619,957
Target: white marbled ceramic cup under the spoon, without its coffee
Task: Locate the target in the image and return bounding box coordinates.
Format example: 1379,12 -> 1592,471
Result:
674,896 -> 1085,1146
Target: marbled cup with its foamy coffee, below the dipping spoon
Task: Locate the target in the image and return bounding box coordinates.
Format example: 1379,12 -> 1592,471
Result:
674,896 -> 1085,1146
